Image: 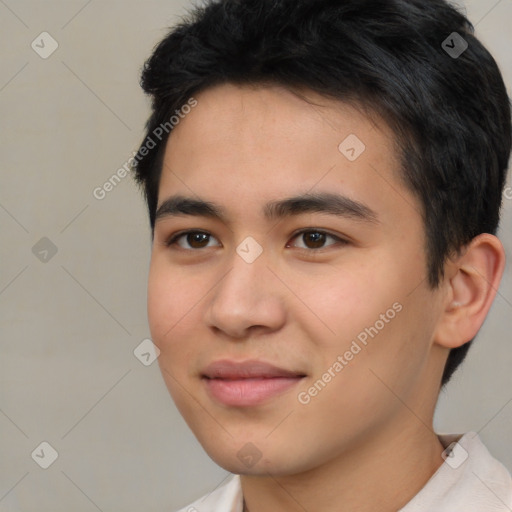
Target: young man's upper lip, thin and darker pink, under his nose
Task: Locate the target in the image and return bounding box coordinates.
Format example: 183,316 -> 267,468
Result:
201,359 -> 305,380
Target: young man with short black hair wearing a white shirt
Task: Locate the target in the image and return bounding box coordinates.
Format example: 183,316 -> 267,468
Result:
135,0 -> 512,512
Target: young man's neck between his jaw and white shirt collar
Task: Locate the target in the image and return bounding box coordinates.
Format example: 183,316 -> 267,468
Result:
241,418 -> 444,512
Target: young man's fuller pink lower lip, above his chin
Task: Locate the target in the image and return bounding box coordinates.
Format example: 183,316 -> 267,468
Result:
203,377 -> 303,407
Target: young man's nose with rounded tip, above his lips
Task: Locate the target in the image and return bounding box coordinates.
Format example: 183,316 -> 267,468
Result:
205,248 -> 286,339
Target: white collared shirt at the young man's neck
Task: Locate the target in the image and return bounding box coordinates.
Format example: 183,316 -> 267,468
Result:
178,432 -> 512,512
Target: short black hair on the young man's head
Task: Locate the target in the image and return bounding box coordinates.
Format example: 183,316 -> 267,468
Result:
134,0 -> 512,385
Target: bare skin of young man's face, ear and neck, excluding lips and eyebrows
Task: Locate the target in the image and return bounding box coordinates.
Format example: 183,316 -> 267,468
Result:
148,84 -> 504,512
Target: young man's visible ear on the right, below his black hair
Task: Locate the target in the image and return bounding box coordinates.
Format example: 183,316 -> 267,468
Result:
434,233 -> 505,349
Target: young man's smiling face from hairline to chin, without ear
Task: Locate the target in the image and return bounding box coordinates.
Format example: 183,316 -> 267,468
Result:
148,84 -> 443,475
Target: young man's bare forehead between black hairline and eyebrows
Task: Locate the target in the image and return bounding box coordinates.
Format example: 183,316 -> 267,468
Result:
158,84 -> 420,228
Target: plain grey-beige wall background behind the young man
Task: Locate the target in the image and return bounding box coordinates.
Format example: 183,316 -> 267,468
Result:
0,0 -> 512,512
